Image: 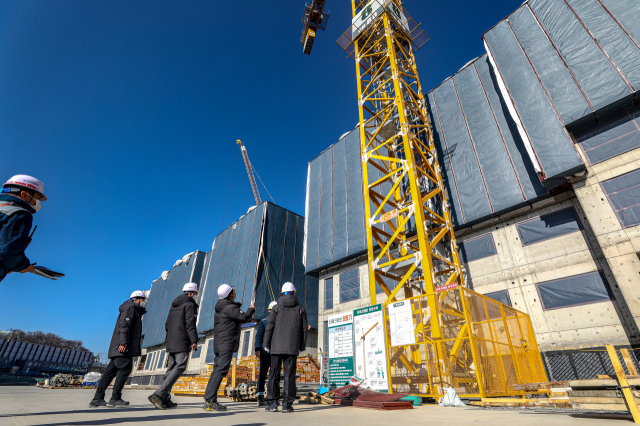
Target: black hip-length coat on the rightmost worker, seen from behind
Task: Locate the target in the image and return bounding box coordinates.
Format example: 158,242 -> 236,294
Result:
262,294 -> 308,355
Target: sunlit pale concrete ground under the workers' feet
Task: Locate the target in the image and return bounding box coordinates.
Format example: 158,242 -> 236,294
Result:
0,386 -> 631,426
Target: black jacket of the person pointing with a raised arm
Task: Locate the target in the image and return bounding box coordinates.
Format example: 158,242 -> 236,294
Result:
213,299 -> 255,354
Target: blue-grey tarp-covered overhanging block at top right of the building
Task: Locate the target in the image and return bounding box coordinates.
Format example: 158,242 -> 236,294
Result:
484,0 -> 640,180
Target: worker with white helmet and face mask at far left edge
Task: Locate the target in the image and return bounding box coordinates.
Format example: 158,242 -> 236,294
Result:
0,175 -> 47,281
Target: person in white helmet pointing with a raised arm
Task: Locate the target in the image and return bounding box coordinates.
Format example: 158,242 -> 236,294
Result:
202,284 -> 255,411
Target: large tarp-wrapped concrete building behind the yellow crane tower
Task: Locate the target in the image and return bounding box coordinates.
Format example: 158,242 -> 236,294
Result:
305,0 -> 640,380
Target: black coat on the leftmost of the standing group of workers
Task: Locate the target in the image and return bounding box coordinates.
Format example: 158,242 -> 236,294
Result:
107,300 -> 147,358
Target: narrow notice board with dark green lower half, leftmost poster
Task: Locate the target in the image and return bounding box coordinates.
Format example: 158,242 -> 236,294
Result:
328,311 -> 354,388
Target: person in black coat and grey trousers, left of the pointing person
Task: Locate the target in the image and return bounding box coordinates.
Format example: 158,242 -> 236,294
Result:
149,283 -> 198,410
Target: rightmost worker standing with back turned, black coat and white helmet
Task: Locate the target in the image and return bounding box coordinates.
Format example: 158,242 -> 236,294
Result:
263,283 -> 309,413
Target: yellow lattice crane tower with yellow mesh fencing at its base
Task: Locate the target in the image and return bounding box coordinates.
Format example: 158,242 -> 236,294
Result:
352,0 -> 546,397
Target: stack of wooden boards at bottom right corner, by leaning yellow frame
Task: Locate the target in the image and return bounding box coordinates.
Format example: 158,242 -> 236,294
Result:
567,375 -> 640,411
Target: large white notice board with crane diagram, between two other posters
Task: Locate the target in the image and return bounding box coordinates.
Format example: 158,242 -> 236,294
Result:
353,305 -> 389,392
